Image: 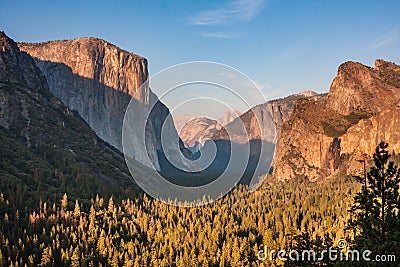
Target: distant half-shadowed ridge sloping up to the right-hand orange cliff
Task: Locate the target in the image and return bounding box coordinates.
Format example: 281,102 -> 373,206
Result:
189,91 -> 326,182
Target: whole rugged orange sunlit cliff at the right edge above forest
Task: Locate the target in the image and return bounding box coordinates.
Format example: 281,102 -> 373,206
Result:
274,60 -> 400,180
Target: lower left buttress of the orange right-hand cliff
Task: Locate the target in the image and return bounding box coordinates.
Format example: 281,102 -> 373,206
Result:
274,99 -> 346,180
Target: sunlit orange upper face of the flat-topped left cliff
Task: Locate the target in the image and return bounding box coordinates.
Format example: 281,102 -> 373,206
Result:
18,38 -> 148,96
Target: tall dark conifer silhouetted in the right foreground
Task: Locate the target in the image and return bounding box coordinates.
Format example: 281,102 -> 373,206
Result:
349,142 -> 400,254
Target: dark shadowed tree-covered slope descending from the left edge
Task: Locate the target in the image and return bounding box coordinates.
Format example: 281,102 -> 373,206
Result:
0,32 -> 146,207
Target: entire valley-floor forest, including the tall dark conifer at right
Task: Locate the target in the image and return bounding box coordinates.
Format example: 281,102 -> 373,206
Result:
0,142 -> 400,267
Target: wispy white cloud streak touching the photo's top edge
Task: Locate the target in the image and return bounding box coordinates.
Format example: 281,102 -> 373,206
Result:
189,0 -> 265,25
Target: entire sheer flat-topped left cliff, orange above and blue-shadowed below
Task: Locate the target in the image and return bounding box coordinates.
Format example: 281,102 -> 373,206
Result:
19,38 -> 183,169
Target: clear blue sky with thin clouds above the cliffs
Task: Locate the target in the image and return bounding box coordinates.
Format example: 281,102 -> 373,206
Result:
0,0 -> 400,116
